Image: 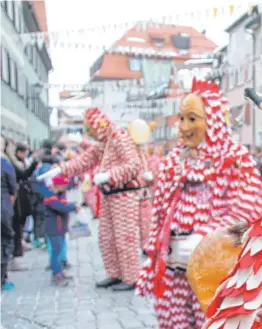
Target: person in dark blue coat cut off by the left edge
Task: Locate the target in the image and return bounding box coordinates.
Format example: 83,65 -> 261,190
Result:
1,136 -> 16,290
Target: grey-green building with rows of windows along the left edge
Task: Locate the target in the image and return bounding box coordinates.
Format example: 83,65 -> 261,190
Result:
1,1 -> 52,148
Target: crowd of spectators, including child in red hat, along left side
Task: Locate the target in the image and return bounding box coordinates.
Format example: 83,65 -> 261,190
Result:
1,136 -> 93,290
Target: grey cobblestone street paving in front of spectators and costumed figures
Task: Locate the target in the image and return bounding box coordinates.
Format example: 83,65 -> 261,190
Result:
2,210 -> 158,329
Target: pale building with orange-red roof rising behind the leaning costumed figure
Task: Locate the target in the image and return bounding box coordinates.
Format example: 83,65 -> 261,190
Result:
90,23 -> 216,123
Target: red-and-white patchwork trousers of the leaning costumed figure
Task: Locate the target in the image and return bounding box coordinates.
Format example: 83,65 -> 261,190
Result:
99,191 -> 140,284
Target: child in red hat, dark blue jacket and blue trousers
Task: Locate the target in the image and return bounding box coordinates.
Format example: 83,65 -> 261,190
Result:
44,176 -> 79,286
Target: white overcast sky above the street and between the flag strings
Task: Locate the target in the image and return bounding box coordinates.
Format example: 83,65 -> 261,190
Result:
46,0 -> 254,84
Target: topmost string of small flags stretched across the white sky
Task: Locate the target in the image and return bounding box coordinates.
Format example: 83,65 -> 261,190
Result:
19,0 -> 260,51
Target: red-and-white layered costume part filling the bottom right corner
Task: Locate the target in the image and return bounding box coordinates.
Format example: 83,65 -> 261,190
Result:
203,215 -> 262,329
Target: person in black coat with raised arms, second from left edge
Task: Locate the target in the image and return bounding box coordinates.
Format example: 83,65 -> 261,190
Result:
7,143 -> 38,271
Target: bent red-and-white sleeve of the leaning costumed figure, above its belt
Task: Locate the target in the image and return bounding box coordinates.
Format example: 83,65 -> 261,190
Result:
109,129 -> 142,186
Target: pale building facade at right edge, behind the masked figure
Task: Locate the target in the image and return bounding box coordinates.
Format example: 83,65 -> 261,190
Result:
222,9 -> 262,145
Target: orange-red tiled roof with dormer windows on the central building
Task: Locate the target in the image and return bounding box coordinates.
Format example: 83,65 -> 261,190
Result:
91,25 -> 217,80
